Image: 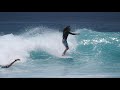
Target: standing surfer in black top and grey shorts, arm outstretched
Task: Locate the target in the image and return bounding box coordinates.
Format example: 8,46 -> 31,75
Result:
62,26 -> 80,56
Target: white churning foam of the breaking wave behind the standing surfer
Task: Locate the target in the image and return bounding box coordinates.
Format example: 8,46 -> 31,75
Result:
0,27 -> 76,65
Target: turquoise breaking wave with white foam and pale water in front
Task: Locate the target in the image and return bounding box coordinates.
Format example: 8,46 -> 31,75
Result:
0,26 -> 120,77
